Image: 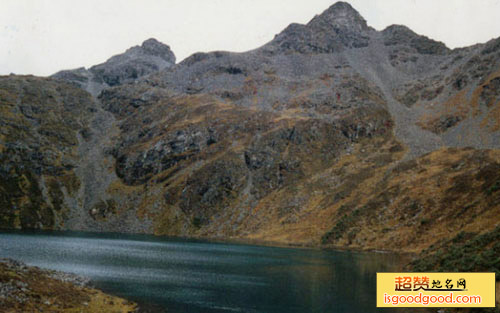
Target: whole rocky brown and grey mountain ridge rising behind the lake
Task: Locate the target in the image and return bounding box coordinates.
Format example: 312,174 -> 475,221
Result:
0,2 -> 500,280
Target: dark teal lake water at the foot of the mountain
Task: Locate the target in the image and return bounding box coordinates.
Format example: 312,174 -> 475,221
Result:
0,233 -> 399,313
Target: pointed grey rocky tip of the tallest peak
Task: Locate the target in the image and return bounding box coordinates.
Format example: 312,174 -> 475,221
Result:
308,1 -> 370,32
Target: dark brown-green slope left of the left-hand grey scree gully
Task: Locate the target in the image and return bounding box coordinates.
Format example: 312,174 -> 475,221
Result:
0,76 -> 98,229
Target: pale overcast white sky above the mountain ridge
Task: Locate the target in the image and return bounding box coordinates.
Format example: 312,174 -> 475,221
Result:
0,0 -> 500,76
